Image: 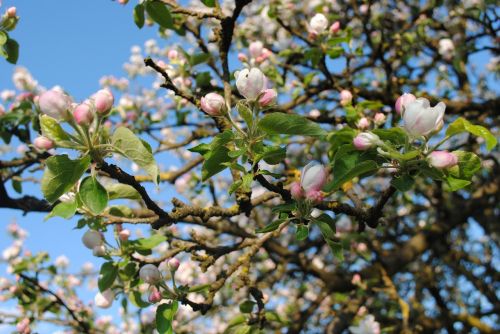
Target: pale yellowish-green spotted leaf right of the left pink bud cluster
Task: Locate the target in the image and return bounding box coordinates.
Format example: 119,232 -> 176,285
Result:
111,127 -> 159,184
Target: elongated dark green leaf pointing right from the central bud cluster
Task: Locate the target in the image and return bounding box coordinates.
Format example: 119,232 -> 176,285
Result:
258,113 -> 326,137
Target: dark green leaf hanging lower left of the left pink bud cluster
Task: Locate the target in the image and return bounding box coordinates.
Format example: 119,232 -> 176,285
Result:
42,155 -> 90,203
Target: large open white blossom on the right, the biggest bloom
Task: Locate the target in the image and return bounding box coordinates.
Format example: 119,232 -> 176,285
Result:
403,98 -> 446,137
